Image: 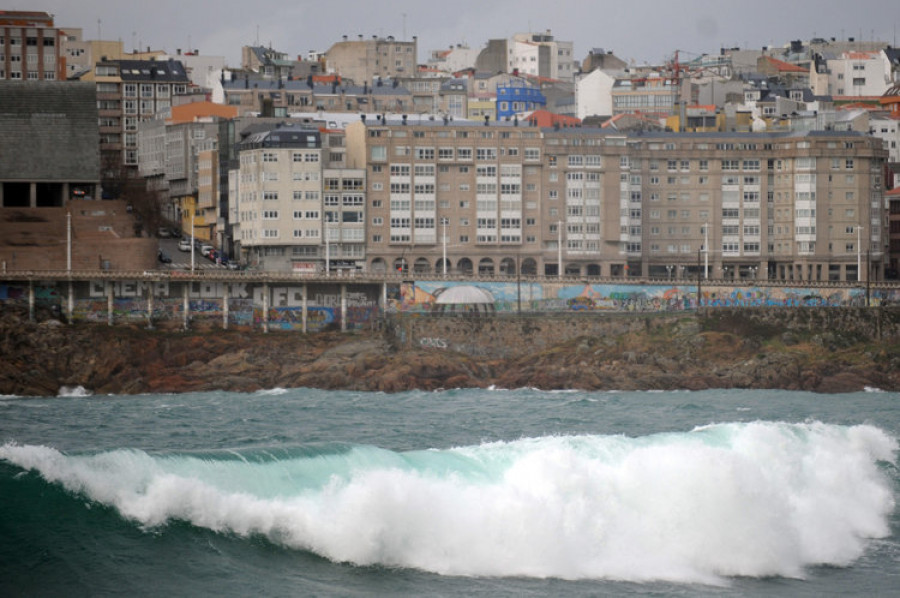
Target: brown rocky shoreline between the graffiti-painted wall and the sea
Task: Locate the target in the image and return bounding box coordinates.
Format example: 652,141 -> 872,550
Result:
0,305 -> 900,396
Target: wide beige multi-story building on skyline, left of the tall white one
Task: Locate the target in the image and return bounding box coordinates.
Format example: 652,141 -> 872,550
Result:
325,35 -> 417,85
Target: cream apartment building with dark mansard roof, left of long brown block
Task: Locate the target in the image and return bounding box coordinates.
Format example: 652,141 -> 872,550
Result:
229,126 -> 366,272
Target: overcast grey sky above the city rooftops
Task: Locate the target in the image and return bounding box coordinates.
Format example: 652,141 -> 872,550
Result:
24,0 -> 900,67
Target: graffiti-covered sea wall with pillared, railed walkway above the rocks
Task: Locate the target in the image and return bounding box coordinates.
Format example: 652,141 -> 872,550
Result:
0,269 -> 900,332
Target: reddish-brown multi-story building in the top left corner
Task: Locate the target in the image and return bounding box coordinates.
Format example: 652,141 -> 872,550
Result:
0,10 -> 66,81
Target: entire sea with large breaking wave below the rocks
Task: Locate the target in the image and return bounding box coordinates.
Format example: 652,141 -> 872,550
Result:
0,389 -> 900,597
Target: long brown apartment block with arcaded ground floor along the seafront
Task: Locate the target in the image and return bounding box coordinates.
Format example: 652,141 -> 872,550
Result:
347,121 -> 887,281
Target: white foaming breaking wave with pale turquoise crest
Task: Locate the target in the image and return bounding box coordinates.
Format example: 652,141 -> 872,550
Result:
0,422 -> 897,583
